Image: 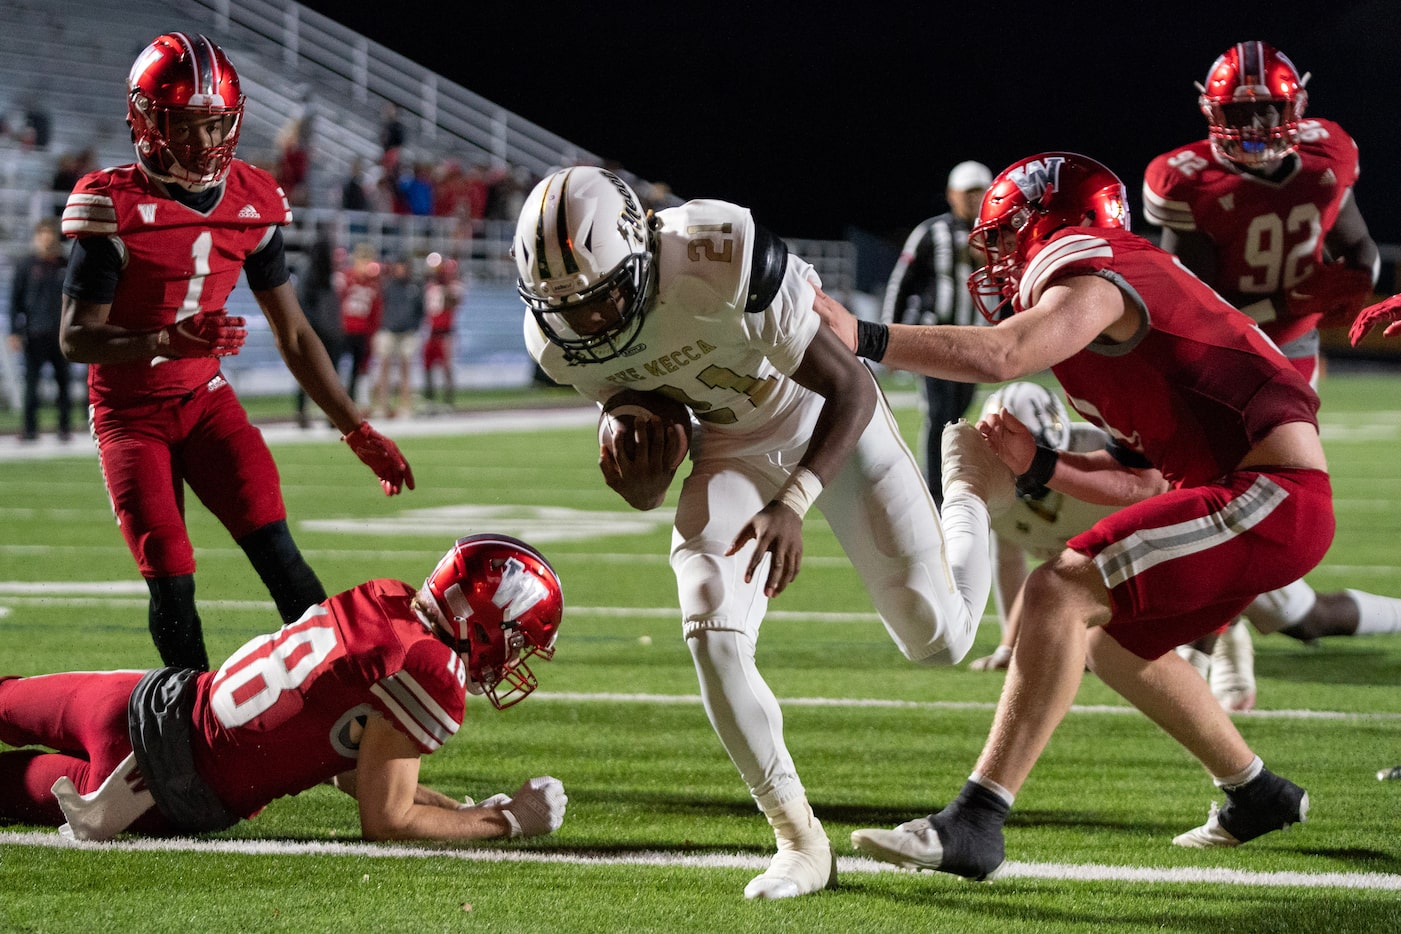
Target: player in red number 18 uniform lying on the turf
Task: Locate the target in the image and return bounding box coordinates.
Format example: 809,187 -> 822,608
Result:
0,534 -> 567,840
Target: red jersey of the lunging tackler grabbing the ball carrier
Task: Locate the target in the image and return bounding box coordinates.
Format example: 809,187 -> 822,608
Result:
1017,227 -> 1318,486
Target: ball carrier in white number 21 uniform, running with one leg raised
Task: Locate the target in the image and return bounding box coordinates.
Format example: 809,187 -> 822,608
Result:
513,167 -> 1013,899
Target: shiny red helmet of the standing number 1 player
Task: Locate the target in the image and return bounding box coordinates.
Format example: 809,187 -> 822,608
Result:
126,32 -> 244,192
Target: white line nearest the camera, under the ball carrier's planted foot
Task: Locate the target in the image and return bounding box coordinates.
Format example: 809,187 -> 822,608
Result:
0,830 -> 1401,891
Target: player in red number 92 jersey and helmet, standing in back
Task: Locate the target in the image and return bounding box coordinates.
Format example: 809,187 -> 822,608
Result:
1143,41 -> 1380,708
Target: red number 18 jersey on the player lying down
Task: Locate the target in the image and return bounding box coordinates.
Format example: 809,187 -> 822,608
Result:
192,580 -> 467,818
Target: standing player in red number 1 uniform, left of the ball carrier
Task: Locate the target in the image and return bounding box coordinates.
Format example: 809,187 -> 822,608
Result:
60,32 -> 413,669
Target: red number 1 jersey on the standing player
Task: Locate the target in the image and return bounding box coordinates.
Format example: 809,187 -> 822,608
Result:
63,160 -> 291,407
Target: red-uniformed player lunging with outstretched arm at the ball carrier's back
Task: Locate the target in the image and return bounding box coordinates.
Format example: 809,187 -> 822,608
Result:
829,153 -> 1334,878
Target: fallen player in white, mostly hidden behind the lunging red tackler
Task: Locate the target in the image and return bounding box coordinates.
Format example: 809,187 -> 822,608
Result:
969,382 -> 1401,710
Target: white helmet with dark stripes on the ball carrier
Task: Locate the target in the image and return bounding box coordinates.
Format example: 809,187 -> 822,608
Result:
511,165 -> 654,363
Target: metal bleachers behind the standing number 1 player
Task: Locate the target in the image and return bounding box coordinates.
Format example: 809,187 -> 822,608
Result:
0,0 -> 856,406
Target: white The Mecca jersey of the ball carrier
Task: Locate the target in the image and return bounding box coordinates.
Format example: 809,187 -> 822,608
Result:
524,200 -> 822,447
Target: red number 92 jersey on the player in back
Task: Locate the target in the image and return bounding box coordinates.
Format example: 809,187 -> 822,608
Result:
1143,119 -> 1359,344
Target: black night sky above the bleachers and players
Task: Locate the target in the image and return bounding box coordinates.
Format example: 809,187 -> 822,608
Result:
295,0 -> 1401,242
